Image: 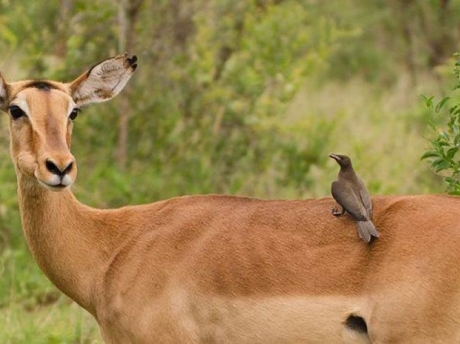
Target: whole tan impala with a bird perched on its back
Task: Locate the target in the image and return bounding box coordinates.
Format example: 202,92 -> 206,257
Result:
0,54 -> 460,344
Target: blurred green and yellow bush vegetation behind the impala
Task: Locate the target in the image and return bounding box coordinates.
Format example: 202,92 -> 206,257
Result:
0,0 -> 460,343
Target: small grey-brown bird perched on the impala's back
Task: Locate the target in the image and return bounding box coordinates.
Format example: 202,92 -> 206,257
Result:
329,154 -> 380,243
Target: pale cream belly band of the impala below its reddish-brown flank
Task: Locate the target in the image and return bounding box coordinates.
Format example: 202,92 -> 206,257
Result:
172,290 -> 367,343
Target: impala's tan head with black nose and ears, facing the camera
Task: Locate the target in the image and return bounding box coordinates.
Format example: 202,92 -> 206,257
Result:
0,54 -> 137,190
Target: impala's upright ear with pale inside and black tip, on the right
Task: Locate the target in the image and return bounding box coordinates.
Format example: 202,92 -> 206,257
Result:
70,53 -> 137,106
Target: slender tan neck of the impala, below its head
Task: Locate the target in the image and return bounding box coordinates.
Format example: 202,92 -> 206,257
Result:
18,173 -> 110,313
